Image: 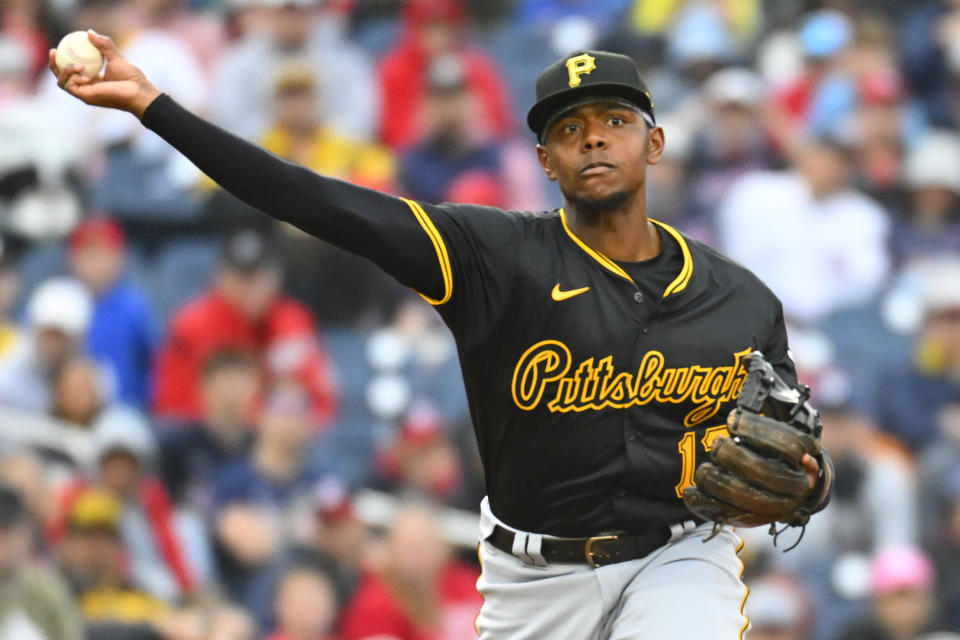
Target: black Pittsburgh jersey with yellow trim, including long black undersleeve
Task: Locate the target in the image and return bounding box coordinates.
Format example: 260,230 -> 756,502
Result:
143,96 -> 796,537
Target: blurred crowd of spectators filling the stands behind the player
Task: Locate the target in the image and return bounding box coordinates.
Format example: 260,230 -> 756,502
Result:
0,0 -> 960,640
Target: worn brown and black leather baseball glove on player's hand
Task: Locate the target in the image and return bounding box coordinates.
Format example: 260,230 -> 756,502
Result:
683,351 -> 834,533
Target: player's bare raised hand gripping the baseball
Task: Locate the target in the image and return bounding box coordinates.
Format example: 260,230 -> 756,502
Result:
50,29 -> 160,118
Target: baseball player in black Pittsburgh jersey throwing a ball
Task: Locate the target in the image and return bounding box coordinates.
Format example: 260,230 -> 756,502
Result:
50,32 -> 830,640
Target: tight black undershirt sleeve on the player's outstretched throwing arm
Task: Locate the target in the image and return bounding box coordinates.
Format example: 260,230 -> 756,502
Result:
141,94 -> 444,297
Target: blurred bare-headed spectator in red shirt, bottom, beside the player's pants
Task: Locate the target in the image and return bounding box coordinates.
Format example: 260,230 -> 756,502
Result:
342,507 -> 482,640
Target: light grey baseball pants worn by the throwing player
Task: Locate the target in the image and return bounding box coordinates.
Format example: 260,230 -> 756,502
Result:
477,498 -> 749,640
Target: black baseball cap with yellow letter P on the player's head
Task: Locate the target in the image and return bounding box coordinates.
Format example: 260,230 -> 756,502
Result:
527,49 -> 656,141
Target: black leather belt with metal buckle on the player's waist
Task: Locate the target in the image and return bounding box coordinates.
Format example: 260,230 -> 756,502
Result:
487,525 -> 670,568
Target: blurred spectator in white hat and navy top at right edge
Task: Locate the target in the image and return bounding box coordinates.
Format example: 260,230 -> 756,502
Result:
891,129 -> 960,264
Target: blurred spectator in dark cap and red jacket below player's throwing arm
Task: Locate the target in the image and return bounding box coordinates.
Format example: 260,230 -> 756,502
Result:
154,230 -> 336,425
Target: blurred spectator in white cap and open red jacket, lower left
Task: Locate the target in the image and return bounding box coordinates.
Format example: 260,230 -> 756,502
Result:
49,407 -> 202,602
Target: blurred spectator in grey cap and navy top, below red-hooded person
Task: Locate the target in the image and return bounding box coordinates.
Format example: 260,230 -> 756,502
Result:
400,55 -> 506,207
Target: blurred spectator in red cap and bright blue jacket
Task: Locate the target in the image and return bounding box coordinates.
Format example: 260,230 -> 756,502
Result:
69,217 -> 156,408
